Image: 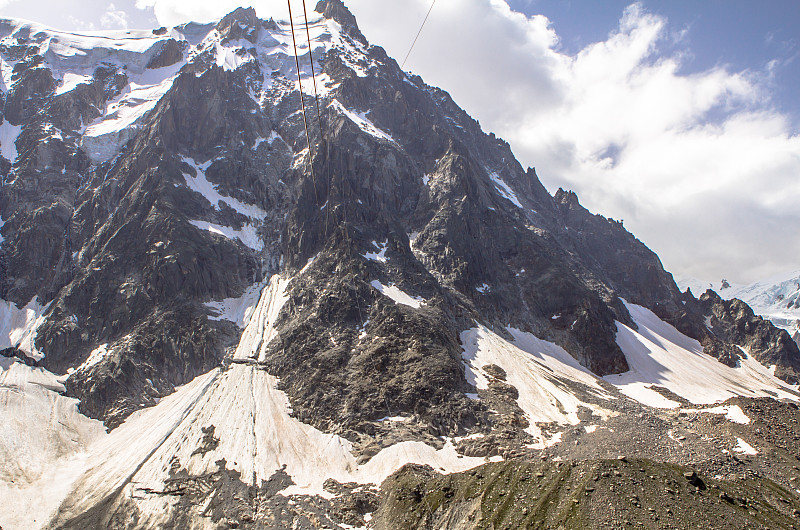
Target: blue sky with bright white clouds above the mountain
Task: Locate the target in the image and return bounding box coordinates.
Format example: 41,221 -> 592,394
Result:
0,0 -> 800,283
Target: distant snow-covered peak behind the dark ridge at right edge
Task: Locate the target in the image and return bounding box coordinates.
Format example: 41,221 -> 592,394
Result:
676,269 -> 800,331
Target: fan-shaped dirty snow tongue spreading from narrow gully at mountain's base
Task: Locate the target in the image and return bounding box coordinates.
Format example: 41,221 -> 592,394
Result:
54,276 -> 485,524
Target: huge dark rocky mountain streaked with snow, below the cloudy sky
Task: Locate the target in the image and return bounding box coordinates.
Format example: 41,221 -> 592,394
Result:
0,0 -> 800,528
